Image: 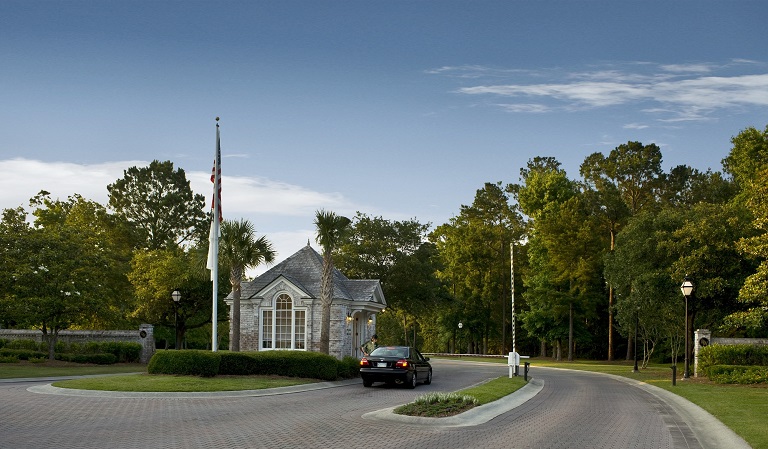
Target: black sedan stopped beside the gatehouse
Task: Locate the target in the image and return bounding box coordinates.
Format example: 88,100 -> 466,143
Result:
360,346 -> 432,388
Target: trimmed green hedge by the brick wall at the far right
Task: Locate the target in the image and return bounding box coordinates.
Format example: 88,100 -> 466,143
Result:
698,345 -> 768,383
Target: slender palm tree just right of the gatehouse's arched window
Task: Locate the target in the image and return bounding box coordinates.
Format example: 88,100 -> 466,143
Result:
315,210 -> 352,354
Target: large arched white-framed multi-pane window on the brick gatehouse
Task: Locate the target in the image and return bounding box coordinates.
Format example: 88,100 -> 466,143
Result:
261,293 -> 306,350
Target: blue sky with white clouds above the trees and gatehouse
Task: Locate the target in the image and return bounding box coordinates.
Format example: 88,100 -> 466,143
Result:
0,0 -> 768,274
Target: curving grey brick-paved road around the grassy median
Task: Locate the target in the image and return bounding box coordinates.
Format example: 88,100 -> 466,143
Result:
0,360 -> 748,449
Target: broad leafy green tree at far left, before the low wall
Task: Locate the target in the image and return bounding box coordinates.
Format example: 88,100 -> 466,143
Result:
0,192 -> 127,359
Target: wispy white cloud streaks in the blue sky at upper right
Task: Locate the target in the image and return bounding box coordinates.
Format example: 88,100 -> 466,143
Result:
439,61 -> 768,121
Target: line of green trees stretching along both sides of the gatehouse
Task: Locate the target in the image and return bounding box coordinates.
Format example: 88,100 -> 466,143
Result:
0,127 -> 768,362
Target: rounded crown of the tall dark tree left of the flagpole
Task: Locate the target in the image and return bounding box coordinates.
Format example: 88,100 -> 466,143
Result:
107,160 -> 210,249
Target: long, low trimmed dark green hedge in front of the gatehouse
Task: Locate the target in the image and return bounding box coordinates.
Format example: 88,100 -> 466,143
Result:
153,350 -> 360,380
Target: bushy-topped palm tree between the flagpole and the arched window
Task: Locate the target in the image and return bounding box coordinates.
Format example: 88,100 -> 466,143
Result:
219,220 -> 276,352
